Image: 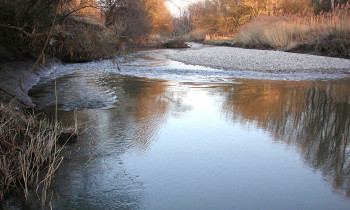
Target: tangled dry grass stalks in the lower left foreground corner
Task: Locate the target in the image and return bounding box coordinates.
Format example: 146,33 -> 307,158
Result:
0,104 -> 67,206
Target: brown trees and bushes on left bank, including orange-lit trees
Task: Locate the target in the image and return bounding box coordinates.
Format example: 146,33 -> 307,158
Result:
0,0 -> 172,62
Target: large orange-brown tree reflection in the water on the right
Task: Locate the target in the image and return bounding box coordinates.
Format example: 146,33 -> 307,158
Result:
221,80 -> 350,197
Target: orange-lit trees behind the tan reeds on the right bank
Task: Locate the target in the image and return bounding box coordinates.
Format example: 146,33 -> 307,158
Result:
174,0 -> 349,34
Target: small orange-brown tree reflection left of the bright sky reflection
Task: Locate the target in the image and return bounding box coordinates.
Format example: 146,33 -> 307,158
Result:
118,77 -> 191,150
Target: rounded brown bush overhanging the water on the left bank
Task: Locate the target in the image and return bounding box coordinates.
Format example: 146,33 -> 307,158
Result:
48,18 -> 121,62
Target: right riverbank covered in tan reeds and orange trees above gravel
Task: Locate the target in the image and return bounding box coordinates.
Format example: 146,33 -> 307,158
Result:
183,1 -> 350,59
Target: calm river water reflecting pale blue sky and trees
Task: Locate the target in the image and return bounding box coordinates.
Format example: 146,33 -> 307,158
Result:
31,48 -> 350,209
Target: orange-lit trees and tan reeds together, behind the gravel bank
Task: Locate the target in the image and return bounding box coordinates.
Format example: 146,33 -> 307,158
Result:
179,0 -> 350,58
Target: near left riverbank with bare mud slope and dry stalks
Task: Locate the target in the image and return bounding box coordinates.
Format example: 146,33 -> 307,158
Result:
0,59 -> 77,209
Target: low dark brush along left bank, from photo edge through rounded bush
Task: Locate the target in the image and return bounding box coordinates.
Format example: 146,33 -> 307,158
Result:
0,17 -> 121,62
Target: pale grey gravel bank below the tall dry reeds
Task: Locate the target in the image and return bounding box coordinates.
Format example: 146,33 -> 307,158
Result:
169,47 -> 350,74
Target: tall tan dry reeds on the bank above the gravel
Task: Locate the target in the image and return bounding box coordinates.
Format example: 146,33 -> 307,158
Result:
235,3 -> 350,57
